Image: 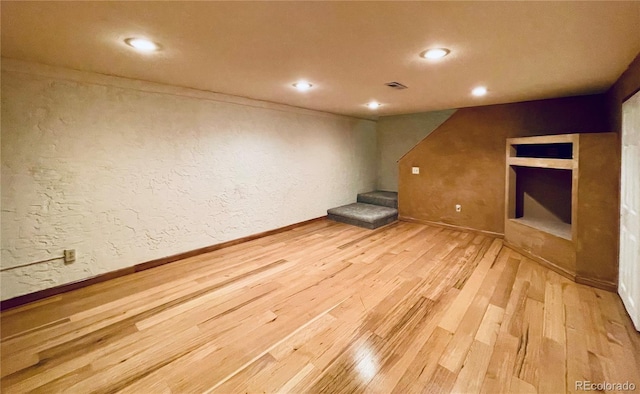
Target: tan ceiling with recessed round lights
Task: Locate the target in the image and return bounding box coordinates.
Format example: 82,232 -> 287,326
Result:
1,1 -> 640,118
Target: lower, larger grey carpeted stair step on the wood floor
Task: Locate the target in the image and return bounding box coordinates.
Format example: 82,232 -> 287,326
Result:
327,202 -> 398,230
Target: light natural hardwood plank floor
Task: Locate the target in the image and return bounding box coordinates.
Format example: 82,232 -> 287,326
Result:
0,220 -> 640,393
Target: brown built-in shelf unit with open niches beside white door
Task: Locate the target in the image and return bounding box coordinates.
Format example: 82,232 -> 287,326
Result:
505,133 -> 617,290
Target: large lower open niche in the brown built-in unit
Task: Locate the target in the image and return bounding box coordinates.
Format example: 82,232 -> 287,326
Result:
513,167 -> 572,240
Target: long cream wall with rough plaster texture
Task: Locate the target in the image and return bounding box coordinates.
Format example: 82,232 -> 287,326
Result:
1,61 -> 376,299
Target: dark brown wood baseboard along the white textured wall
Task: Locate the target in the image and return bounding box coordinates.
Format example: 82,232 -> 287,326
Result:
0,216 -> 326,311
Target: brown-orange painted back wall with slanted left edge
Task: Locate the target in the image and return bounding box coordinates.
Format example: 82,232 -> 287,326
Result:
398,95 -> 615,233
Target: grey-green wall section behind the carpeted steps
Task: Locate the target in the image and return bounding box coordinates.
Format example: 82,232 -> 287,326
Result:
376,109 -> 455,192
